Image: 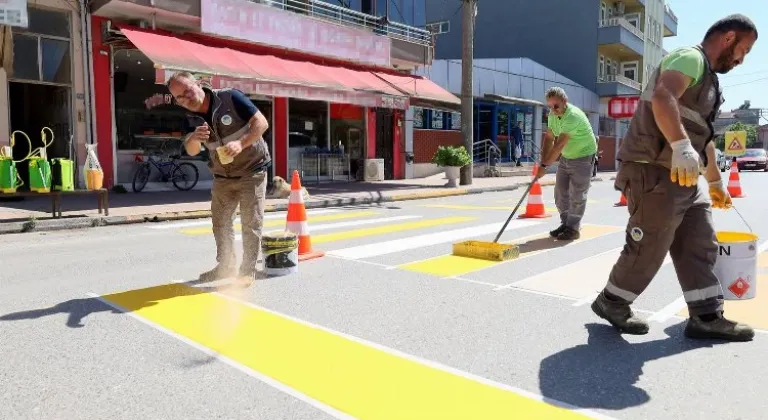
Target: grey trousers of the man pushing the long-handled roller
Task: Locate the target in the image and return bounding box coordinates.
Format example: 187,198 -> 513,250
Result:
555,155 -> 595,230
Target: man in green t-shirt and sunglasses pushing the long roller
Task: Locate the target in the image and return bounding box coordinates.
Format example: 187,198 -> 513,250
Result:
536,87 -> 597,241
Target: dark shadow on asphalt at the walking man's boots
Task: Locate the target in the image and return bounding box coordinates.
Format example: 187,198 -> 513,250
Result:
539,322 -> 723,410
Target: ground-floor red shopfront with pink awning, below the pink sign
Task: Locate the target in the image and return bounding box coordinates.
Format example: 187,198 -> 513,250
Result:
93,18 -> 458,185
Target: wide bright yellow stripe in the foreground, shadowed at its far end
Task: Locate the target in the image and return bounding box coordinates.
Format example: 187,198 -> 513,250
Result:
104,284 -> 588,420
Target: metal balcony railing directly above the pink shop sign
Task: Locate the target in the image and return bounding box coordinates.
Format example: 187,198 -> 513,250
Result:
248,0 -> 432,47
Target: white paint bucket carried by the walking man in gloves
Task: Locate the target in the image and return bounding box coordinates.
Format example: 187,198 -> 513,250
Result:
715,232 -> 758,300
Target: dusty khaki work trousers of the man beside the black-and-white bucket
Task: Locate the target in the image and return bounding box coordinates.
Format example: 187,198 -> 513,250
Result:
211,172 -> 267,274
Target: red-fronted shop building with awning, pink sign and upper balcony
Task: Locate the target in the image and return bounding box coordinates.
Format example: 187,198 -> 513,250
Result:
85,0 -> 460,185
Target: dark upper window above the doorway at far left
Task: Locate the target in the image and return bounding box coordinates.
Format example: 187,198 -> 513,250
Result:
13,7 -> 72,85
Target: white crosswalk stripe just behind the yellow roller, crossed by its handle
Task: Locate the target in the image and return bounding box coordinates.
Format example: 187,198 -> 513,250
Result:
326,220 -> 541,260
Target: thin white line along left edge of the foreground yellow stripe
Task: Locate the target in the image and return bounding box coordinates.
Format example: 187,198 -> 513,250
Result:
88,293 -> 355,420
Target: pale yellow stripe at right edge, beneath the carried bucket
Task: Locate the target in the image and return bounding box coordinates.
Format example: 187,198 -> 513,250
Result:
677,251 -> 768,330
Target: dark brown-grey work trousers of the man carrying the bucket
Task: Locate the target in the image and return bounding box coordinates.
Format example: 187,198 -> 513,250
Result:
605,162 -> 723,316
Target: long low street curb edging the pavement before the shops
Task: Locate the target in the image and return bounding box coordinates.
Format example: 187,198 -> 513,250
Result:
0,178 -> 568,235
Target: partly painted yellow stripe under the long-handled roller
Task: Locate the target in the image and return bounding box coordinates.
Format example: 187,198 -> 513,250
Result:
398,225 -> 624,277
